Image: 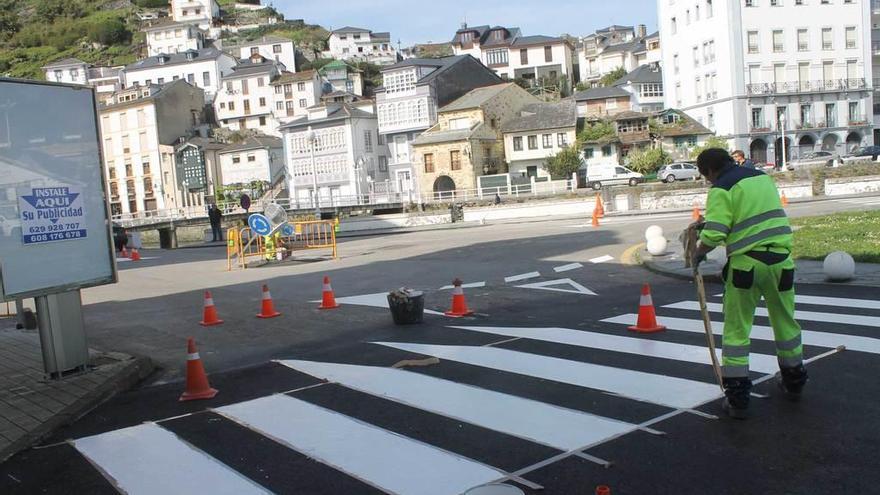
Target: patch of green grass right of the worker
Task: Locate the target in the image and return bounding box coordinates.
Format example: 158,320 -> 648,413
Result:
792,211 -> 880,263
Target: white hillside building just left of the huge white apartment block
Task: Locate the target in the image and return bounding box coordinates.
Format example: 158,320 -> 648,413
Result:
577,24 -> 661,86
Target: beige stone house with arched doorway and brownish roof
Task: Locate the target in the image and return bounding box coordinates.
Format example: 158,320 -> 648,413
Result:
412,83 -> 539,193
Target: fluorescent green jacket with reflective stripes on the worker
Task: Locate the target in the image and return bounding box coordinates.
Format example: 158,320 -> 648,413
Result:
700,166 -> 792,257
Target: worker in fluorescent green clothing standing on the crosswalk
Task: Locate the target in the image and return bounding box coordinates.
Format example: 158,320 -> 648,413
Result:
692,148 -> 807,419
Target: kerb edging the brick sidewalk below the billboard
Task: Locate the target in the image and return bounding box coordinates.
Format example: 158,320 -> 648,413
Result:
0,352 -> 156,462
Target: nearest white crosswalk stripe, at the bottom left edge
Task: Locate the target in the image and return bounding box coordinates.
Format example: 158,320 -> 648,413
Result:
73,423 -> 270,495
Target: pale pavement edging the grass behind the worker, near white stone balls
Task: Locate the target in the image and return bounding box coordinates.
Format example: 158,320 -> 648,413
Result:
635,235 -> 880,287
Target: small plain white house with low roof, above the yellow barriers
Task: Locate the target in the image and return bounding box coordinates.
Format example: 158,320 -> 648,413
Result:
217,136 -> 284,186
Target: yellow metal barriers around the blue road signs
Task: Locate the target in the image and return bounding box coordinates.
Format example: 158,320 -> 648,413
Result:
226,220 -> 337,271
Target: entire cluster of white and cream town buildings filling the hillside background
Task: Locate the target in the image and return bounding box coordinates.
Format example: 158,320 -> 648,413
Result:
29,0 -> 880,214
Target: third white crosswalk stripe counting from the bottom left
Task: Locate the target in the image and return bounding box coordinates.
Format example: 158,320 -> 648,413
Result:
279,360 -> 637,451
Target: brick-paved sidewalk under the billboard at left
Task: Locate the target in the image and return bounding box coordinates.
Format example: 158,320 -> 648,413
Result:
0,326 -> 153,462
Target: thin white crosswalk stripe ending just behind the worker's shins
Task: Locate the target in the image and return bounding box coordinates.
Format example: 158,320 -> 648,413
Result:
452,326 -> 779,373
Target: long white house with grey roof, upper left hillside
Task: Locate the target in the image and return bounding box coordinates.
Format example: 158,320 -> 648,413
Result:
123,47 -> 235,103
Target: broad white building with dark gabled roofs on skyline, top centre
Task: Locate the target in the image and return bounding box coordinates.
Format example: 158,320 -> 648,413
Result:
452,24 -> 575,87
